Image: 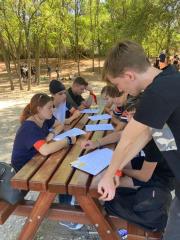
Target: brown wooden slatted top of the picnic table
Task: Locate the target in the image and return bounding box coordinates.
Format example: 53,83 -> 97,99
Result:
12,109 -> 114,195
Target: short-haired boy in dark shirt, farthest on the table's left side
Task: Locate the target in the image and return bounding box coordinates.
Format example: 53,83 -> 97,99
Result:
66,77 -> 97,110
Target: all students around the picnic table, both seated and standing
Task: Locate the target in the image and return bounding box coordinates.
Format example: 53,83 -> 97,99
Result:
12,41 -> 180,240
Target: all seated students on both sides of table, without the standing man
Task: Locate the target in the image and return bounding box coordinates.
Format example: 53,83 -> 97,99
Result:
11,66 -> 174,235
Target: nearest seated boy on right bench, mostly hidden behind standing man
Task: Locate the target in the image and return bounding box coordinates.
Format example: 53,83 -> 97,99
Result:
81,97 -> 174,191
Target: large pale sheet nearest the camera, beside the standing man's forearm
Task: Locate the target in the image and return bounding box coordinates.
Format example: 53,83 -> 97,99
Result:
71,148 -> 113,175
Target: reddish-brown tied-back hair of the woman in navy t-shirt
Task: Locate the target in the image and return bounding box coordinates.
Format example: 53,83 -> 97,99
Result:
20,93 -> 52,123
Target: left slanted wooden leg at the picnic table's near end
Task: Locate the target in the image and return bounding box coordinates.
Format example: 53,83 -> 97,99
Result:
18,192 -> 56,240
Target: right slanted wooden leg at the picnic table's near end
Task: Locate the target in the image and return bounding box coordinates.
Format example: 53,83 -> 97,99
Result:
76,195 -> 119,240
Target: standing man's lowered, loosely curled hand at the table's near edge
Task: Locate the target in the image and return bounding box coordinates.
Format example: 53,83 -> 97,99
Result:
98,175 -> 116,201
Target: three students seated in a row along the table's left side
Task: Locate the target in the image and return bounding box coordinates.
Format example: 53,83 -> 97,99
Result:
11,77 -> 96,229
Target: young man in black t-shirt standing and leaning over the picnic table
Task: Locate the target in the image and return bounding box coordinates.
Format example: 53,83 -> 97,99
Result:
98,41 -> 180,240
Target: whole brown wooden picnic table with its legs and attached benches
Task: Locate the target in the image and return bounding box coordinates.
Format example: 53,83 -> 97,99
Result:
0,114 -> 162,240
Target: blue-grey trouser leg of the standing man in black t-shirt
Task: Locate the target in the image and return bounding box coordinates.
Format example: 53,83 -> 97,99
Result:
163,197 -> 180,240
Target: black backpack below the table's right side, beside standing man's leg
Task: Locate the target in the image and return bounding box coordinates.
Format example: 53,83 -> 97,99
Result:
105,187 -> 172,231
